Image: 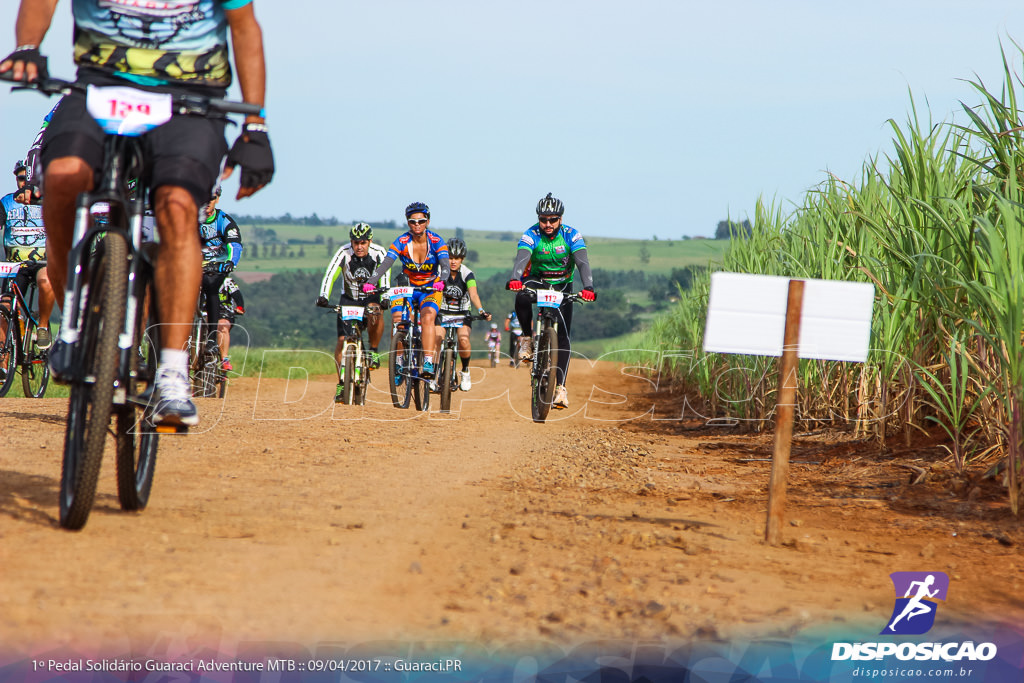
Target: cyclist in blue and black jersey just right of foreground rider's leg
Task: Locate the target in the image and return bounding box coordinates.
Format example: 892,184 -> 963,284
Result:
199,186 -> 243,365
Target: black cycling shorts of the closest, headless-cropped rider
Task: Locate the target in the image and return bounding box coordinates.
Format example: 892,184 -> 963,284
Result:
42,71 -> 227,207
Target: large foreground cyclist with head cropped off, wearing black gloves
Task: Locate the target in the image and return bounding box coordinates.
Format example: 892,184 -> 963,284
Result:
0,0 -> 273,425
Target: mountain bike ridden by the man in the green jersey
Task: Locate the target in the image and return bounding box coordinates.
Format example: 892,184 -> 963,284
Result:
523,284 -> 584,422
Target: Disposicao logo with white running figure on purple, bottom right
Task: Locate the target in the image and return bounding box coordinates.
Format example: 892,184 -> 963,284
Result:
831,571 -> 997,661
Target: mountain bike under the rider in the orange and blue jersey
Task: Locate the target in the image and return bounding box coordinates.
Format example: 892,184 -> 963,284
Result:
387,286 -> 433,411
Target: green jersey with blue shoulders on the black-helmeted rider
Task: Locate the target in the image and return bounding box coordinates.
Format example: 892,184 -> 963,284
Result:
512,224 -> 594,287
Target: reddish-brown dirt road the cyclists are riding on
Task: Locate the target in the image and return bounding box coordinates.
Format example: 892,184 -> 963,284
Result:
0,364 -> 1024,654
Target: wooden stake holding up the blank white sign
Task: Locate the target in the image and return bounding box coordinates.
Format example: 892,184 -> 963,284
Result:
765,280 -> 804,546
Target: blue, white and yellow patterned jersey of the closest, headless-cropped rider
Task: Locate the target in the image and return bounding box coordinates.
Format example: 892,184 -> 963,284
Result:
72,0 -> 252,88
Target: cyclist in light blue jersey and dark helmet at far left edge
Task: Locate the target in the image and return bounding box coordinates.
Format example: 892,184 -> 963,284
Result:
0,160 -> 54,349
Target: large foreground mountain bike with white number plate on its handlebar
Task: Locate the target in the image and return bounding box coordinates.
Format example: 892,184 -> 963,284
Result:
6,79 -> 261,529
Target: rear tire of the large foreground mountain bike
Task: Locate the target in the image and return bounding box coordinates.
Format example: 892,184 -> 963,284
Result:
116,268 -> 160,510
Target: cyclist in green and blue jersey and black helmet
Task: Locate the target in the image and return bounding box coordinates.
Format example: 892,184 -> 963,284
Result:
508,193 -> 597,409
